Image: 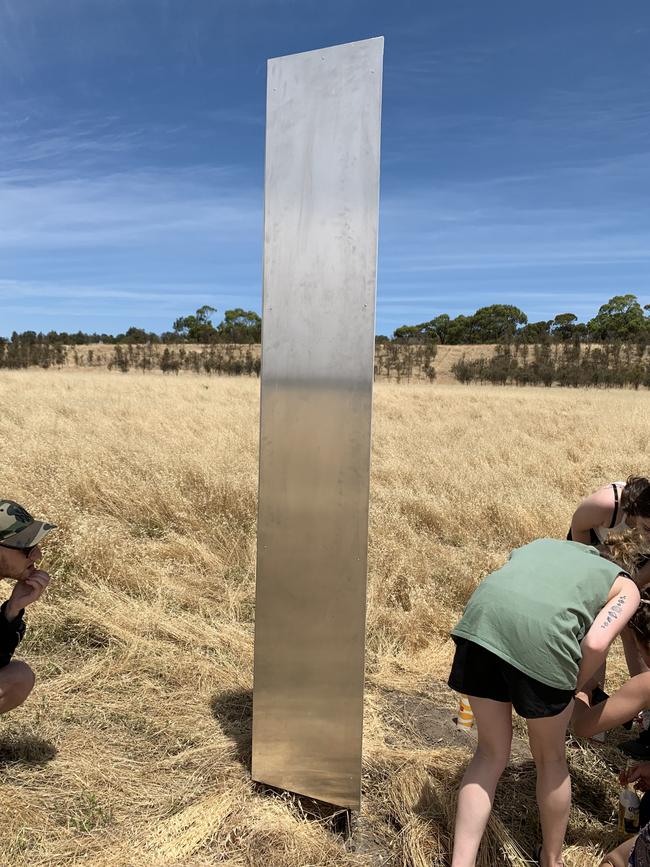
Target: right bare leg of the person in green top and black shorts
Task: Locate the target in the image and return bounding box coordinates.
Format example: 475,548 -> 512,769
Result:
526,702 -> 573,867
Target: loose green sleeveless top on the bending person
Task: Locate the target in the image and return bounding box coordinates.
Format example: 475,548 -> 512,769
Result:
451,539 -> 624,689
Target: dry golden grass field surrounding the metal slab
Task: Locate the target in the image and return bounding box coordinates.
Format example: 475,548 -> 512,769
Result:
0,370 -> 650,867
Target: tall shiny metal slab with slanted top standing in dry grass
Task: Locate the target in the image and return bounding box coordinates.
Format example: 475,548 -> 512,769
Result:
252,38 -> 384,808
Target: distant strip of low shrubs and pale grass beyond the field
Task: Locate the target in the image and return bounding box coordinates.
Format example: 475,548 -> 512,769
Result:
6,338 -> 650,389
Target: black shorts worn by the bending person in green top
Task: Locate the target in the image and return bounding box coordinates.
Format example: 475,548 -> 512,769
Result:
448,636 -> 575,719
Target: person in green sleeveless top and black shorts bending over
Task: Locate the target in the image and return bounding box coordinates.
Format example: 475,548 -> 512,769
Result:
449,539 -> 639,867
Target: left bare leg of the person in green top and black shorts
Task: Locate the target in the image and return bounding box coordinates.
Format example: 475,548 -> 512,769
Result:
451,696 -> 512,867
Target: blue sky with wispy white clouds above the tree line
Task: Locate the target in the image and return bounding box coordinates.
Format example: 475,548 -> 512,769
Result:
0,0 -> 650,335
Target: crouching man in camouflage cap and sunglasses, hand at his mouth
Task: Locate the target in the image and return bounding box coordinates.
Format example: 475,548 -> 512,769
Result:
0,500 -> 56,714
